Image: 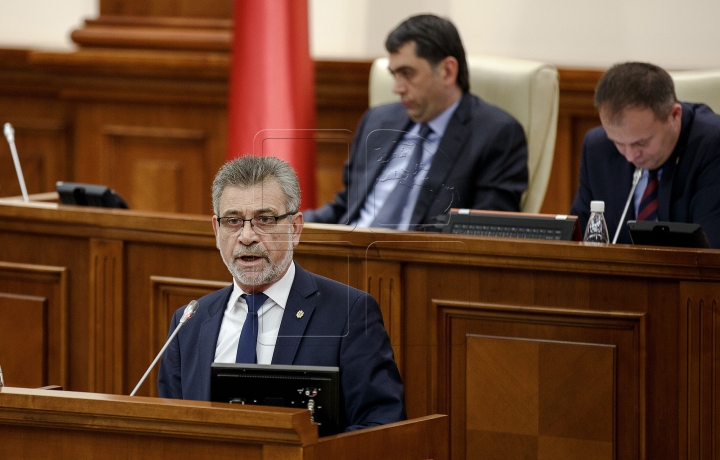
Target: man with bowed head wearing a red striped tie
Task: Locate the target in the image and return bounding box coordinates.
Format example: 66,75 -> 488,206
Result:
570,62 -> 720,248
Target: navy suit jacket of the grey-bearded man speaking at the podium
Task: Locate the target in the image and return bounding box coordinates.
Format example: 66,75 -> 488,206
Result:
158,264 -> 407,430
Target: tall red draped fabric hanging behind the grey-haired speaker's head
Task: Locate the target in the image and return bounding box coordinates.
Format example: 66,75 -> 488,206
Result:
227,0 -> 315,209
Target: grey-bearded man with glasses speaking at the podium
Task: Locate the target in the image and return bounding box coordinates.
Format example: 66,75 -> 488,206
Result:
158,156 -> 407,430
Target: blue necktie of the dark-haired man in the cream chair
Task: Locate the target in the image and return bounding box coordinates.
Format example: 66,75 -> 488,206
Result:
370,124 -> 431,228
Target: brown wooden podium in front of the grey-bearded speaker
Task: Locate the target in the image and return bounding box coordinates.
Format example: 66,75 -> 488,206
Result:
0,387 -> 449,460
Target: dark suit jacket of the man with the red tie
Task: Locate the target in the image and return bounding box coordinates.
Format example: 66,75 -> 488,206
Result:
570,103 -> 720,248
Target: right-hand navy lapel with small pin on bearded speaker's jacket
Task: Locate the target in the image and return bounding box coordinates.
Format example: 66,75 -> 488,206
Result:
272,263 -> 317,364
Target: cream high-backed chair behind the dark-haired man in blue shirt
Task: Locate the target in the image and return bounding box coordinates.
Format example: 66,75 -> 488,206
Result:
370,56 -> 560,212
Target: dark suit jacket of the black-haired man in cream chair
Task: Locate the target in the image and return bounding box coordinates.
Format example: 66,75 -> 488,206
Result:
303,93 -> 528,229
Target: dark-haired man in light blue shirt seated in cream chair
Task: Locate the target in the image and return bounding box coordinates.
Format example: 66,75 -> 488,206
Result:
305,15 -> 528,230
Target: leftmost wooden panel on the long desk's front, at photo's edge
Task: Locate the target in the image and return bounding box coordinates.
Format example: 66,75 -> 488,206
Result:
0,261 -> 70,387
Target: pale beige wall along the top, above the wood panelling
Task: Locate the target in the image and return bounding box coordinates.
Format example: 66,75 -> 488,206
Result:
0,0 -> 720,69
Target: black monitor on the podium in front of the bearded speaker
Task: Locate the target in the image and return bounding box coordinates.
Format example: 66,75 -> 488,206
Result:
210,363 -> 341,436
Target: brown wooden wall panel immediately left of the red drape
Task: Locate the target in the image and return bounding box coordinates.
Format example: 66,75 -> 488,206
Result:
74,104 -> 224,214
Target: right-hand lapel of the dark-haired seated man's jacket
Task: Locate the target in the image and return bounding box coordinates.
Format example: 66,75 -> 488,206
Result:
410,93 -> 471,224
